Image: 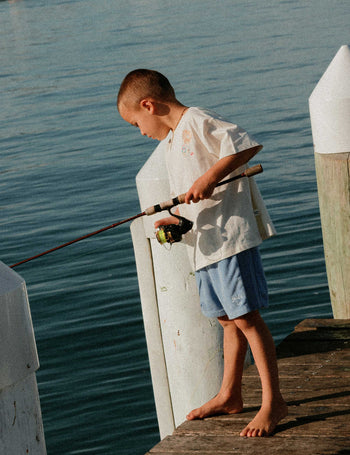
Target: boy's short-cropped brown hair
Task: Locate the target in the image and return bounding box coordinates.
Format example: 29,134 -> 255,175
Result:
117,69 -> 176,108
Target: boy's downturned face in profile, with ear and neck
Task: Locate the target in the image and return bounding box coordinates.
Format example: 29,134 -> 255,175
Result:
119,100 -> 170,141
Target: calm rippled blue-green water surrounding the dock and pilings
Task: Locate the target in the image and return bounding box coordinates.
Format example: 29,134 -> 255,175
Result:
0,0 -> 350,455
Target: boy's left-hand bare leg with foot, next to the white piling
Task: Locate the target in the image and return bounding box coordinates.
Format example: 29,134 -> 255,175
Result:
187,316 -> 247,420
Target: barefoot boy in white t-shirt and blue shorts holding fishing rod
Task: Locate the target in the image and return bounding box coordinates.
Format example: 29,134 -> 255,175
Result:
117,69 -> 288,437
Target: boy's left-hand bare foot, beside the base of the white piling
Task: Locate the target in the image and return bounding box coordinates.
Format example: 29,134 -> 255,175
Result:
186,394 -> 243,420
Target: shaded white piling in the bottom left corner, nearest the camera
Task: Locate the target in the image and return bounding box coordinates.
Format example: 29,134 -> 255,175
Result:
0,262 -> 46,455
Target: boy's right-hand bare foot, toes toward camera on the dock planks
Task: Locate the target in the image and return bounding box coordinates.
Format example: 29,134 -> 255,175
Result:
240,401 -> 288,438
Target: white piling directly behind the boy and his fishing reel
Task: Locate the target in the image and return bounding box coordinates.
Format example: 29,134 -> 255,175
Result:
131,144 -> 223,438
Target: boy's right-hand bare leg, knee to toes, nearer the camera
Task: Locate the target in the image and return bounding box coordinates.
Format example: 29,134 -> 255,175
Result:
235,311 -> 288,437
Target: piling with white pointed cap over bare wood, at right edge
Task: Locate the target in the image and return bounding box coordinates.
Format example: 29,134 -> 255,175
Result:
309,45 -> 350,319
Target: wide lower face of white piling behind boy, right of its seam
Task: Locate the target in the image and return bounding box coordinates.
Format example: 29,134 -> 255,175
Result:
151,239 -> 223,427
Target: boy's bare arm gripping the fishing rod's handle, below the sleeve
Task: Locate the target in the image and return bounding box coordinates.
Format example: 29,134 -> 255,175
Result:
185,145 -> 262,204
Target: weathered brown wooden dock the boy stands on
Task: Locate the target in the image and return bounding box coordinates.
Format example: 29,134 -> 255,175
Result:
146,319 -> 350,455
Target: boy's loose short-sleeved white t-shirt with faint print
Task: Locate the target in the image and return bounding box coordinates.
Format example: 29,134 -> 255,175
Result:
164,107 -> 274,270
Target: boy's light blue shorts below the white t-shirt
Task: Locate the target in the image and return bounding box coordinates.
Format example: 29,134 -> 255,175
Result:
196,248 -> 268,319
